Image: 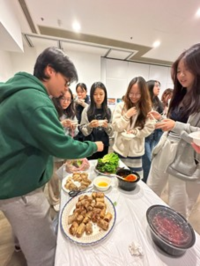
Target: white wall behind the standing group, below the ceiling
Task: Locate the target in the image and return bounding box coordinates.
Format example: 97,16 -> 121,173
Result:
0,46 -> 173,98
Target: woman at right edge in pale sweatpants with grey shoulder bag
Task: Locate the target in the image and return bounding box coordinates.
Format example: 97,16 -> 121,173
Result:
148,44 -> 200,218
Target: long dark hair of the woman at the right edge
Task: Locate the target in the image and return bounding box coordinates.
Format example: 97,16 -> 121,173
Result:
169,43 -> 200,117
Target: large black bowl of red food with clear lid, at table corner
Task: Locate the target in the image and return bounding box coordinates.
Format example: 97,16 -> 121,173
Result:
146,205 -> 196,257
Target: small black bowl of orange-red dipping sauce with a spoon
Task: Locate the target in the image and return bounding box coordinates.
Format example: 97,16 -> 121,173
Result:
116,168 -> 140,191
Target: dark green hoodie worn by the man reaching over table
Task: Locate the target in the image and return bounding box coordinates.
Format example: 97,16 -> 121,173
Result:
0,72 -> 97,199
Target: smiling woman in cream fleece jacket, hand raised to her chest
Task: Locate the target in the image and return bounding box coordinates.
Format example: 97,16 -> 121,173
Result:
112,77 -> 154,178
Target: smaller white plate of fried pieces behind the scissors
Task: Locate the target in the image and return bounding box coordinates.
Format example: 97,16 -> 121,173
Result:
62,172 -> 92,193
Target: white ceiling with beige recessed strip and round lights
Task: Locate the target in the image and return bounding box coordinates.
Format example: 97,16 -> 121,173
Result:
13,0 -> 200,65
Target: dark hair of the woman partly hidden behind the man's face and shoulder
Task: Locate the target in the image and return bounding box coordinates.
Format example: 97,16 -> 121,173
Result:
52,88 -> 75,119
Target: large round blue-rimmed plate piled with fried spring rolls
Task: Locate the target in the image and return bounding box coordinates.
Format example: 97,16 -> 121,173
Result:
60,192 -> 116,245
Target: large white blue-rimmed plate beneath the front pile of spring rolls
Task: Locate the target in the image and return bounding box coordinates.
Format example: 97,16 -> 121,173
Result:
60,192 -> 116,246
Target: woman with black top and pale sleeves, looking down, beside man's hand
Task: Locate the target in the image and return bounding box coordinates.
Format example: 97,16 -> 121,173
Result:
80,82 -> 113,160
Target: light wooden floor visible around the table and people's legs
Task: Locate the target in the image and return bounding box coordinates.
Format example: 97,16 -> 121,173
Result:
0,184 -> 200,266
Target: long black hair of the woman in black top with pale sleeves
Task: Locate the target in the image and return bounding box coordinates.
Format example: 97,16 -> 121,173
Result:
87,82 -> 111,121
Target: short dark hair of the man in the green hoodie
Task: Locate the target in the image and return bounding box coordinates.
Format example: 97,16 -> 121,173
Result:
33,47 -> 78,82
